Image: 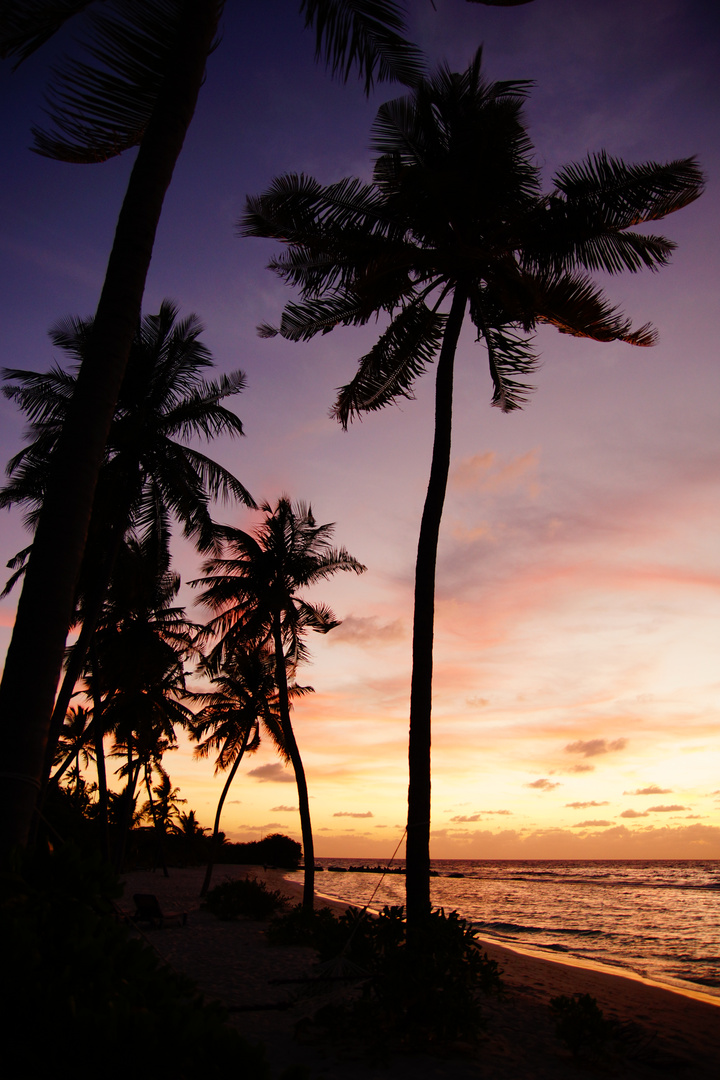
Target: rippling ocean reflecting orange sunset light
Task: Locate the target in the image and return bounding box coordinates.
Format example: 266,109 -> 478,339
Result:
288,859 -> 720,998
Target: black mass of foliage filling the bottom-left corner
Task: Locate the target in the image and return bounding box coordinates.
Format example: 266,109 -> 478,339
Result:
0,847 -> 268,1080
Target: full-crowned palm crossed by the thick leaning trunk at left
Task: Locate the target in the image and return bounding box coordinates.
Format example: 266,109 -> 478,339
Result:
0,300 -> 255,781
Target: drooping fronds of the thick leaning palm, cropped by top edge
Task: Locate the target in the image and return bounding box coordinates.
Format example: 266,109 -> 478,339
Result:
0,0 -> 424,163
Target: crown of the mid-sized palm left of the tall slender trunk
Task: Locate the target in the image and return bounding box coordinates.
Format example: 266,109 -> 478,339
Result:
191,496 -> 365,670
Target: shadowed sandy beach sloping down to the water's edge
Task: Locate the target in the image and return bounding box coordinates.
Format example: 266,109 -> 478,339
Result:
119,866 -> 720,1080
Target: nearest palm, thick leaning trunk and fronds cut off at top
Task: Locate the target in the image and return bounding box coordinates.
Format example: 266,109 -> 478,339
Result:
0,0 -> 422,848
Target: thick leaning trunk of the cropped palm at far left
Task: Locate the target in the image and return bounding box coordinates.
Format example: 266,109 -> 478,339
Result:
0,0 -> 221,850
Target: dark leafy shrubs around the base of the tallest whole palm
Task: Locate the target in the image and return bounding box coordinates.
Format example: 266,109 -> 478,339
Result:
268,907 -> 502,1049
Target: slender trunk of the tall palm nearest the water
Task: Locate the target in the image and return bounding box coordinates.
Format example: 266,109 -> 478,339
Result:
405,286 -> 467,930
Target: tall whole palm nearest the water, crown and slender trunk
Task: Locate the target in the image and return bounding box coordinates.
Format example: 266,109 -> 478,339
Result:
241,51 -> 703,922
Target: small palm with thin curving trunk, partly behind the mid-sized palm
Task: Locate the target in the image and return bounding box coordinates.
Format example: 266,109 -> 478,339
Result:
192,642 -> 311,896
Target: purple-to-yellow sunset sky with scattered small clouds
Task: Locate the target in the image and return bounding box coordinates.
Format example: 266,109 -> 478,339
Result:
0,0 -> 720,860
